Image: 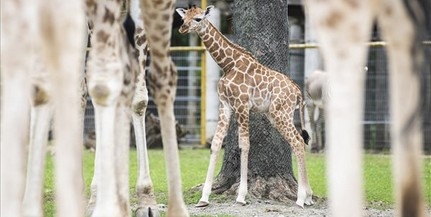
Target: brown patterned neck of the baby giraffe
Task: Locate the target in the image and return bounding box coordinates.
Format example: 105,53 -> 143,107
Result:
197,20 -> 253,72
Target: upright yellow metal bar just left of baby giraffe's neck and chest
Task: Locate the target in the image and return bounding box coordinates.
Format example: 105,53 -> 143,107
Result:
201,0 -> 207,147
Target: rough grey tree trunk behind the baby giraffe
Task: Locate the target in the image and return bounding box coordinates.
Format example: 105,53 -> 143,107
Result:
213,0 -> 297,201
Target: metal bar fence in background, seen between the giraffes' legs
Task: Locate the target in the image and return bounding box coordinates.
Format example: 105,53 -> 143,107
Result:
85,43 -> 431,150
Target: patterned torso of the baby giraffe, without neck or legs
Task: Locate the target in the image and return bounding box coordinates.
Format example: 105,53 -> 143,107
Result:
218,55 -> 302,112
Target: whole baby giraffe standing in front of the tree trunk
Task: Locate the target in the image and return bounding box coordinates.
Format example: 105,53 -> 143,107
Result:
176,6 -> 313,207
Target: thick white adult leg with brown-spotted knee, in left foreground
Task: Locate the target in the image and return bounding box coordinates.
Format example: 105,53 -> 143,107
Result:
86,0 -> 135,216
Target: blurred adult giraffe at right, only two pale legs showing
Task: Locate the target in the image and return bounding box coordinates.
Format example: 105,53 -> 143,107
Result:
305,0 -> 429,217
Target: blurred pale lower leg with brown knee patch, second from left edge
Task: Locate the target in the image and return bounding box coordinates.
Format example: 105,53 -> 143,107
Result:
23,78 -> 52,217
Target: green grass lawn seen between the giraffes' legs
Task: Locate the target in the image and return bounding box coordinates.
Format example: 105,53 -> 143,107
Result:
44,149 -> 431,217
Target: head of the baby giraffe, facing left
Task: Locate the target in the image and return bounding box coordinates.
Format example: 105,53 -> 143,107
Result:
176,5 -> 214,34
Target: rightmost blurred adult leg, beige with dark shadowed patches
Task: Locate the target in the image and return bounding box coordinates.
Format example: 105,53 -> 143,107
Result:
378,1 -> 426,216
